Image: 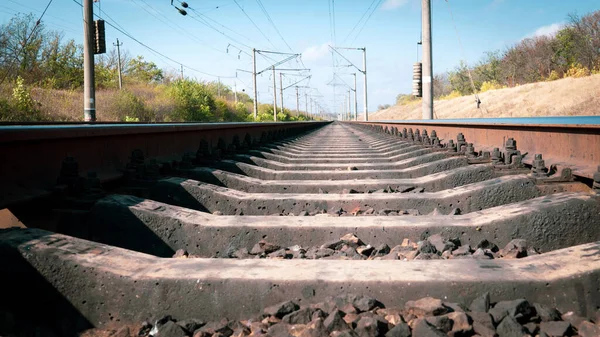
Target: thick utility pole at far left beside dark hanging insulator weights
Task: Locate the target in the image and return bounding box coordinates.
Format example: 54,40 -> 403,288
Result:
83,0 -> 96,122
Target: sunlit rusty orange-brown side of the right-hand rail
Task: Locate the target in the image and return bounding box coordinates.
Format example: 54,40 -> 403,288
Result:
350,121 -> 600,178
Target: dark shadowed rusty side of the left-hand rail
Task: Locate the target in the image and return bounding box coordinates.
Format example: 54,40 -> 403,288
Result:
0,122 -> 327,208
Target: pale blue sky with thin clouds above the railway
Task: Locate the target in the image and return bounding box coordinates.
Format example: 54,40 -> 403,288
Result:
0,0 -> 600,112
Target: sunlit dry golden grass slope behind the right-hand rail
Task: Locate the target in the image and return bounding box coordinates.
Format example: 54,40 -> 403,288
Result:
369,75 -> 600,120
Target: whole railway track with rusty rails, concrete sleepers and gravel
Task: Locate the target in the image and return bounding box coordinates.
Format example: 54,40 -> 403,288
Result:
0,122 -> 600,337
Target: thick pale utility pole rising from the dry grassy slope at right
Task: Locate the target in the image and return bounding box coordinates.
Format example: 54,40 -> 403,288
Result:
421,0 -> 433,119
